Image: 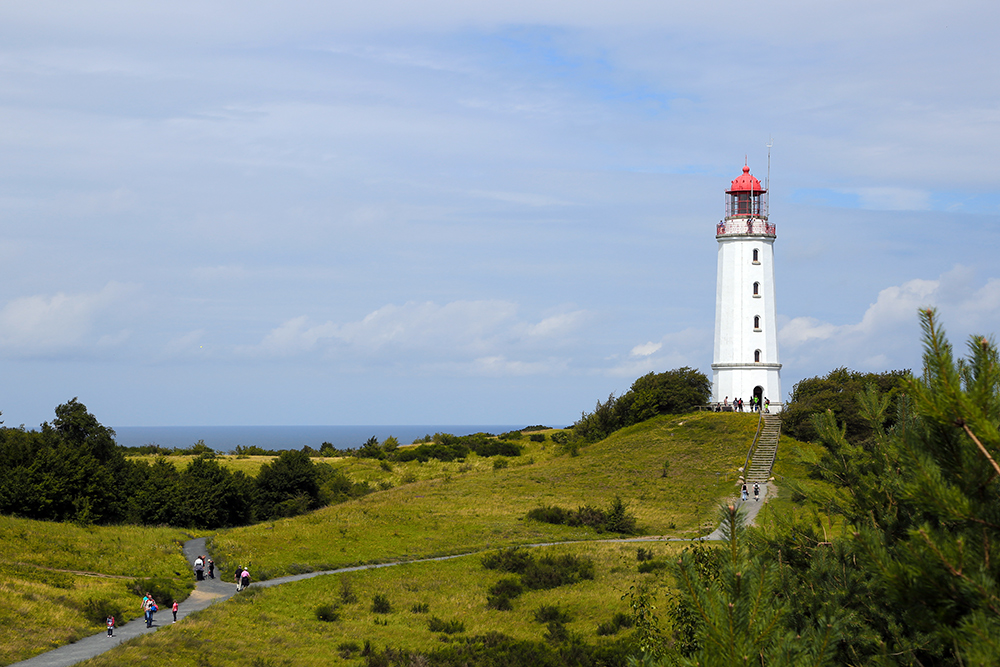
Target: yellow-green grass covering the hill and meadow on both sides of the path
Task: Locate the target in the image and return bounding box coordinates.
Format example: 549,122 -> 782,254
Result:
0,413 -> 812,665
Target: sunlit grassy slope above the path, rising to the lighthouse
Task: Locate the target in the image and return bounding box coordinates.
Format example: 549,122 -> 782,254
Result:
211,413 -> 757,577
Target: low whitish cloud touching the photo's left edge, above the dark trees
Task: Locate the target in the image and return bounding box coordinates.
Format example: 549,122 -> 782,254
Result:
0,282 -> 138,357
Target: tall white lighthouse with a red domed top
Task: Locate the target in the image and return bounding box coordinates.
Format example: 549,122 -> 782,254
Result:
712,166 -> 781,412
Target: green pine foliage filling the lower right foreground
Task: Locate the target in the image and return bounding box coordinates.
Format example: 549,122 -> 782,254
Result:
631,310 -> 1000,667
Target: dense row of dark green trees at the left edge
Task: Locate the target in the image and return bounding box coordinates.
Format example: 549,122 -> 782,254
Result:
0,398 -> 373,528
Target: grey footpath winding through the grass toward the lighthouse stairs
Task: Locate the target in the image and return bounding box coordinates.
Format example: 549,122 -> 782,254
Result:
9,484 -> 768,667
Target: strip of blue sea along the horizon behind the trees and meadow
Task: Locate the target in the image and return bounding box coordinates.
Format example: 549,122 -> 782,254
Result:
112,424 -> 531,452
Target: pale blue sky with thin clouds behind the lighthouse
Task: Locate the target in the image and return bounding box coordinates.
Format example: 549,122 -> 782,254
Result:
0,0 -> 1000,428
